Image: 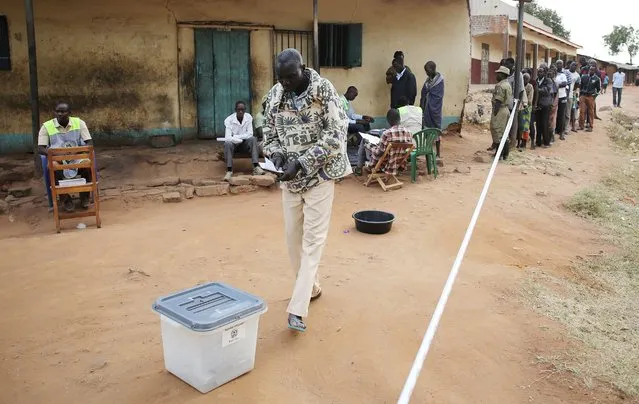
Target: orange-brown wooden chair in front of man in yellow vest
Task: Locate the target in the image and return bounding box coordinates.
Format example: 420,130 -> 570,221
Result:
47,146 -> 102,233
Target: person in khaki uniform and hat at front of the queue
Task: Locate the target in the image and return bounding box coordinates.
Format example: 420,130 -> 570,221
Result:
488,66 -> 513,160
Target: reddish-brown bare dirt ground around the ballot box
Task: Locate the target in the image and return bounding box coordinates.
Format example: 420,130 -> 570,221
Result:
0,88 -> 639,404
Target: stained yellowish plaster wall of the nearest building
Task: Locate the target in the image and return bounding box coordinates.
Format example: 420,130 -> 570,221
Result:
0,0 -> 470,152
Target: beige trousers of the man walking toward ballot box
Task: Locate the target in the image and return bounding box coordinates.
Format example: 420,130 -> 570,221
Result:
282,181 -> 335,317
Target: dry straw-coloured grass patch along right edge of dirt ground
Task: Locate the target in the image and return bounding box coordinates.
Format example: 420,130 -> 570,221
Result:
524,112 -> 639,397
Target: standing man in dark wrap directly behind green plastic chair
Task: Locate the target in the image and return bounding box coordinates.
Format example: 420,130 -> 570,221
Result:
419,61 -> 444,158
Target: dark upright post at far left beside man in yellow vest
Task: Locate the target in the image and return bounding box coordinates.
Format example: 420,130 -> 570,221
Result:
24,0 -> 42,174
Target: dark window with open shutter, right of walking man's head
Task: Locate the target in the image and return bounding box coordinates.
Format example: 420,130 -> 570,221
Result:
319,24 -> 362,68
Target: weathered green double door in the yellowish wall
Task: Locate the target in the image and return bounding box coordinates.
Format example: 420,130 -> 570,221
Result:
195,28 -> 251,139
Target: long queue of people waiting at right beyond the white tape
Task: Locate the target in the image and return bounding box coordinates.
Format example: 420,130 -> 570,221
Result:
488,58 -> 625,159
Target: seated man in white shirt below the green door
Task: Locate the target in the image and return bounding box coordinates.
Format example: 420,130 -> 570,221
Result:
224,101 -> 264,181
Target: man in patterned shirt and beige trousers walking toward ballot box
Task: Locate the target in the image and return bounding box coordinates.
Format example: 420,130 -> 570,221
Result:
264,49 -> 351,332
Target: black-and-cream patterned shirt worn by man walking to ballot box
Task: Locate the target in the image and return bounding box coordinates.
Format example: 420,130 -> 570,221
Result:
264,69 -> 352,193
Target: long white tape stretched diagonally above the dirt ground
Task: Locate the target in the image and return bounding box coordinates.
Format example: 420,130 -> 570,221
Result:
397,100 -> 519,404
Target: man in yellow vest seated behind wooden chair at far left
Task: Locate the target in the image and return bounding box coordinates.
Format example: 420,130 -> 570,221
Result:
38,102 -> 92,212
